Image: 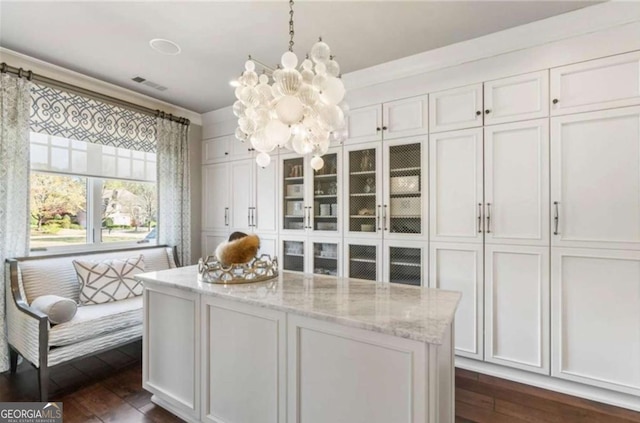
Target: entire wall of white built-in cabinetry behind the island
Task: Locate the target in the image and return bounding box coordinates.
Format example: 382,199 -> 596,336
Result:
203,48 -> 640,410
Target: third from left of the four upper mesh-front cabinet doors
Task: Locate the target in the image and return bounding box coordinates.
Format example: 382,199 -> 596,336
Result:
345,144 -> 382,238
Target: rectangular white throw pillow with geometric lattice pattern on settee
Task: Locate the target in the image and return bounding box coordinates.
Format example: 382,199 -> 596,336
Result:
73,254 -> 144,304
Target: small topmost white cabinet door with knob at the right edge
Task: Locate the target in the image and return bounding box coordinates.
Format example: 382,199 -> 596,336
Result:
551,52 -> 640,115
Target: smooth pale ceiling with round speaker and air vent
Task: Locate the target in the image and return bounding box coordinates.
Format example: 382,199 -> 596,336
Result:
0,0 -> 595,113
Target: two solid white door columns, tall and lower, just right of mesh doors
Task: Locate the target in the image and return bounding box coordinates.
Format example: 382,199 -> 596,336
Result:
430,119 -> 549,364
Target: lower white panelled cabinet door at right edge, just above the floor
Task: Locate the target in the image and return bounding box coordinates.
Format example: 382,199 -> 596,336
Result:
551,248 -> 640,395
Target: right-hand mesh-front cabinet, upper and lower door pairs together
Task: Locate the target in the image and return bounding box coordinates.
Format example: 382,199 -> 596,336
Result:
344,136 -> 428,285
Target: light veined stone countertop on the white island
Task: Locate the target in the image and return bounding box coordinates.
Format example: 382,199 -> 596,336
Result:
136,266 -> 462,344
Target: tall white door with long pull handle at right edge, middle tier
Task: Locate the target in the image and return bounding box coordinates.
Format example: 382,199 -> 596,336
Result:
551,107 -> 640,250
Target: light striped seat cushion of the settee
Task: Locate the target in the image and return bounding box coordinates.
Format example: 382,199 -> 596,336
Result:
49,296 -> 142,347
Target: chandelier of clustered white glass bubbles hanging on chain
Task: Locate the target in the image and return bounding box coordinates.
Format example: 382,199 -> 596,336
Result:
231,0 -> 348,170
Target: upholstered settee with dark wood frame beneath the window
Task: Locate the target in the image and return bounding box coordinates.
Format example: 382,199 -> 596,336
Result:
6,246 -> 177,401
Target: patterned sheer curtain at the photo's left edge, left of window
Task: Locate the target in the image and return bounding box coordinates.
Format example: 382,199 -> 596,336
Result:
0,73 -> 31,372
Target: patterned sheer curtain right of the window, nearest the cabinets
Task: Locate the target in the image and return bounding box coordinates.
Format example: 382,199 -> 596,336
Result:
156,118 -> 191,266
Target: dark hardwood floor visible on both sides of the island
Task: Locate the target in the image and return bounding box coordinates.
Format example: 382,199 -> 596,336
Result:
0,342 -> 640,423
